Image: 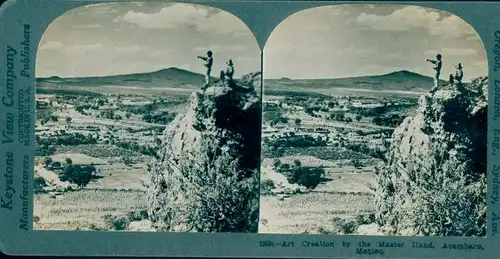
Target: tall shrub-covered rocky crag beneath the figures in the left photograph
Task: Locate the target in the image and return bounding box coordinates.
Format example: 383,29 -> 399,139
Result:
148,73 -> 261,232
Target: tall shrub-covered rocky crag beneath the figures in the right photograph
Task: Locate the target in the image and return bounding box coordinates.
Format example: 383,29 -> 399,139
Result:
377,77 -> 488,236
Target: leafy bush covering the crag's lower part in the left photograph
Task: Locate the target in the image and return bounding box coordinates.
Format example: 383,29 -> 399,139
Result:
149,138 -> 259,233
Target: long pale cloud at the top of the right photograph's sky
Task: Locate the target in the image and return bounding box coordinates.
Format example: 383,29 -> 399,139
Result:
355,6 -> 475,38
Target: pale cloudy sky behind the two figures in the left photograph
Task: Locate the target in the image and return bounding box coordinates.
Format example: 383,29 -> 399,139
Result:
36,3 -> 261,77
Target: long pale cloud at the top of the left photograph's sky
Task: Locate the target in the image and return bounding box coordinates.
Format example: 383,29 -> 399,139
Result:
114,4 -> 248,33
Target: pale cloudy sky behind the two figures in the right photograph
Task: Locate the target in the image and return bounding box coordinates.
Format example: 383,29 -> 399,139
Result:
263,5 -> 488,81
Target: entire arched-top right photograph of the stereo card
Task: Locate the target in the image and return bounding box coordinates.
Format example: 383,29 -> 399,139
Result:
259,4 -> 488,237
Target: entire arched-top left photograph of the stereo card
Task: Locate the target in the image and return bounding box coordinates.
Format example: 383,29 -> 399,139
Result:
33,2 -> 262,233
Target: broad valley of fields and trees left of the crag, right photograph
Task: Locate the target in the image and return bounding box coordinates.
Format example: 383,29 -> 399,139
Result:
259,83 -> 421,235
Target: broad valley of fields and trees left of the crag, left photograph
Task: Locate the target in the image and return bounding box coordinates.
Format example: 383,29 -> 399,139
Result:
34,83 -> 192,231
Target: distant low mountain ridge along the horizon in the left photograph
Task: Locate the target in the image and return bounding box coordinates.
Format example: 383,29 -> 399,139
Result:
36,67 -> 211,88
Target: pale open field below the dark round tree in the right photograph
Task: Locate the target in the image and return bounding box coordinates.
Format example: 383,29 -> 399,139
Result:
259,160 -> 375,234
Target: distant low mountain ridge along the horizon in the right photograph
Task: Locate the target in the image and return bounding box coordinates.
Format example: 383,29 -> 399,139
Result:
264,70 -> 446,92
